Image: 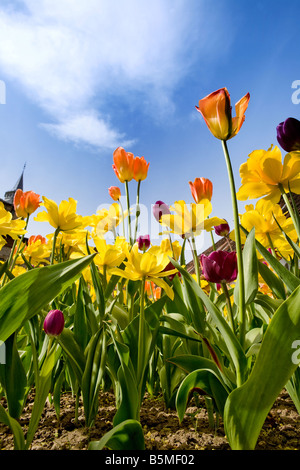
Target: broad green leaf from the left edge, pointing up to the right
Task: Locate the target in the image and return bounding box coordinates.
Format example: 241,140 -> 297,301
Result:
0,255 -> 94,341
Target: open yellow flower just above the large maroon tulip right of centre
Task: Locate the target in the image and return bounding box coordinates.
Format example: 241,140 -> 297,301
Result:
161,199 -> 225,238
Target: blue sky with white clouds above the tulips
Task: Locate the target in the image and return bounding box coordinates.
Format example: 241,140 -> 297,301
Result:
0,0 -> 300,258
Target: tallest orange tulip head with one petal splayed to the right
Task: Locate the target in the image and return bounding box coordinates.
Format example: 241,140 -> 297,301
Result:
196,88 -> 250,140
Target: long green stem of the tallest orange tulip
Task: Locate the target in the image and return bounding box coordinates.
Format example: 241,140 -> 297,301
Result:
222,140 -> 246,347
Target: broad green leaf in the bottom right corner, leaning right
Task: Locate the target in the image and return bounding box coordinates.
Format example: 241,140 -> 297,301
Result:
224,287 -> 300,450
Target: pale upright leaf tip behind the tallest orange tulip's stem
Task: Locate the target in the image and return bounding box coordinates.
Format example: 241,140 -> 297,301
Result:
234,228 -> 258,305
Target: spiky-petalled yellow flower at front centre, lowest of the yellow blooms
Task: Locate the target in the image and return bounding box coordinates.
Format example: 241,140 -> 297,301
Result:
111,243 -> 177,299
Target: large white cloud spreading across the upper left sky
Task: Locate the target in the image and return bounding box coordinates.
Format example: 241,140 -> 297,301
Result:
0,0 -> 227,148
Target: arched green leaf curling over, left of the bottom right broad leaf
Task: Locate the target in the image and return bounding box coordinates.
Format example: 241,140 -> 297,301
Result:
176,369 -> 228,422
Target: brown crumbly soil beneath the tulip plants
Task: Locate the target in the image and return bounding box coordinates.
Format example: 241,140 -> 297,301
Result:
0,391 -> 300,451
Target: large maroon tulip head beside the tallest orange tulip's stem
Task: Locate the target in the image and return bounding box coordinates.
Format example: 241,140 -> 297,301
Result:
200,250 -> 237,284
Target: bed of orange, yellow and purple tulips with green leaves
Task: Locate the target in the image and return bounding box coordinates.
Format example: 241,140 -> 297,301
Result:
0,89 -> 300,450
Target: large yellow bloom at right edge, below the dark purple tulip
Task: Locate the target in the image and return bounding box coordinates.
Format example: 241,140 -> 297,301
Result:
237,146 -> 300,203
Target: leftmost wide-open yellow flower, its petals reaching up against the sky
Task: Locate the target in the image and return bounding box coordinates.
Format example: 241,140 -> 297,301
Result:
34,196 -> 89,232
